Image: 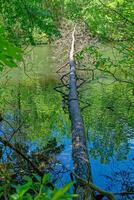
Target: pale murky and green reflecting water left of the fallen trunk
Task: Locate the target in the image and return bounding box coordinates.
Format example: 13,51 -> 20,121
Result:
0,46 -> 69,146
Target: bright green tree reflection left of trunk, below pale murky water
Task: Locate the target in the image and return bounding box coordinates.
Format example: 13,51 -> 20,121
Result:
0,80 -> 68,145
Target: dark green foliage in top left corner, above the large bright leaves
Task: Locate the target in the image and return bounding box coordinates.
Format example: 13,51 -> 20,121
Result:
0,0 -> 59,46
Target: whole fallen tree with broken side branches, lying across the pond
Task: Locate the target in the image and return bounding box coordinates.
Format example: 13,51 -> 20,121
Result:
54,28 -> 115,200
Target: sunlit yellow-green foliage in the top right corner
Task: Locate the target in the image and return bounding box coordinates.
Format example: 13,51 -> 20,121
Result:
65,0 -> 134,40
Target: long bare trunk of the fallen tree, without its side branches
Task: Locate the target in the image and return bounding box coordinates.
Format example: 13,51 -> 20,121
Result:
68,28 -> 94,200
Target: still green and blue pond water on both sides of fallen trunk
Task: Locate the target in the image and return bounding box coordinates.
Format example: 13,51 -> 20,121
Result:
0,46 -> 134,200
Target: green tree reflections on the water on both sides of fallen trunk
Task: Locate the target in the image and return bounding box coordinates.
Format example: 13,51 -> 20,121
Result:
0,46 -> 134,163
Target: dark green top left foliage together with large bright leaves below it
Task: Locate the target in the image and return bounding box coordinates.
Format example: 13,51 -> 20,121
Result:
0,0 -> 60,71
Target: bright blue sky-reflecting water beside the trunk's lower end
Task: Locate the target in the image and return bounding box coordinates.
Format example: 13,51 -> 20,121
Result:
58,134 -> 134,200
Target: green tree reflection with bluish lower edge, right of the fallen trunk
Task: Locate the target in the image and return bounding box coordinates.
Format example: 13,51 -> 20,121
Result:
81,80 -> 134,163
